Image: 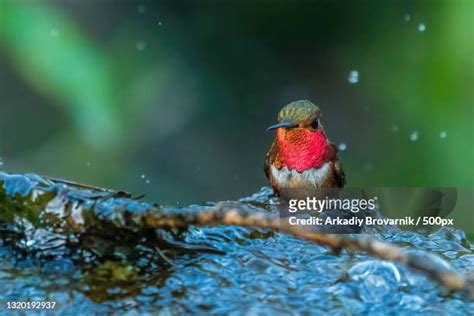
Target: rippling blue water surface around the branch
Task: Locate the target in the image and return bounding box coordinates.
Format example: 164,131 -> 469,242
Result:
0,174 -> 474,315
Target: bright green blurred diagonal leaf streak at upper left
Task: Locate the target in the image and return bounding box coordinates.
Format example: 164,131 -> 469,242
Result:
0,1 -> 119,146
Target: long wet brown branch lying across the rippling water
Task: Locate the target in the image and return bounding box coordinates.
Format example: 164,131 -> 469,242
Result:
0,173 -> 474,299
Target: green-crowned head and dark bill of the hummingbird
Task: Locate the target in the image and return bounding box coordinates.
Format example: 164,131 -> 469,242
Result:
267,100 -> 321,131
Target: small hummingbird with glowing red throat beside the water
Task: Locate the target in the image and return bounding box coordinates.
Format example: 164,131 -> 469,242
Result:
264,100 -> 345,199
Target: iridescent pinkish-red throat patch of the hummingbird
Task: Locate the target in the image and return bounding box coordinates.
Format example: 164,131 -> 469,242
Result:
277,128 -> 332,172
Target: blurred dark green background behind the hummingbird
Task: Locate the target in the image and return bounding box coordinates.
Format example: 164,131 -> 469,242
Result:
0,0 -> 474,204
